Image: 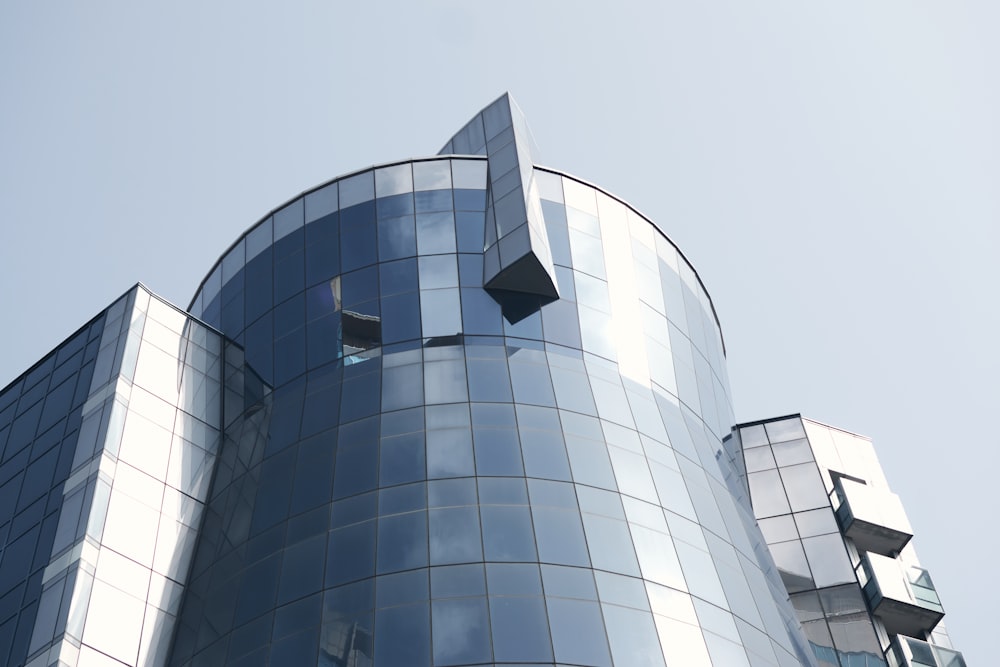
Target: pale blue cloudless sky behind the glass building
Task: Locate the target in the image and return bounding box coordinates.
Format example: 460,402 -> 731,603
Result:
0,0 -> 1000,665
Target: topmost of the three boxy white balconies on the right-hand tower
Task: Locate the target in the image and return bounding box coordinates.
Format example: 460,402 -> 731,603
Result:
833,477 -> 913,556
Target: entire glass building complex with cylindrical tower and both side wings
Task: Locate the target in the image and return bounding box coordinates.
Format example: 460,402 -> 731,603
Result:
0,95 -> 964,667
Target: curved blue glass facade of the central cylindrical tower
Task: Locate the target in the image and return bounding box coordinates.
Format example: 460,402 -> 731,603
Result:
173,96 -> 810,667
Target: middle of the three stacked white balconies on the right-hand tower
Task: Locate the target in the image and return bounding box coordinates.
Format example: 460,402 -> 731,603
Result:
859,553 -> 944,640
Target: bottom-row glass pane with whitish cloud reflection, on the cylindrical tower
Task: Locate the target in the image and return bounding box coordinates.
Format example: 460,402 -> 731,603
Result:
431,598 -> 491,665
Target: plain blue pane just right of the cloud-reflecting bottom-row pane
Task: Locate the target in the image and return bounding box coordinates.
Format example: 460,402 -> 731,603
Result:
490,597 -> 552,664
